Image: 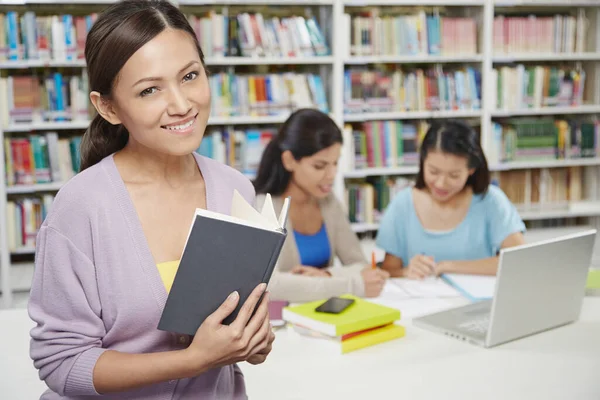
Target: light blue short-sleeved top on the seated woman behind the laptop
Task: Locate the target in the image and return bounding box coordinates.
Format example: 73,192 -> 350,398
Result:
376,185 -> 525,266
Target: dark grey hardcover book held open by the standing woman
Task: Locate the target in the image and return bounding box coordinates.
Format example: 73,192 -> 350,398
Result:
158,191 -> 289,335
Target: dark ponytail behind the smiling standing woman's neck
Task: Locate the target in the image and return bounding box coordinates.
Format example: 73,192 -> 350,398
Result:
79,114 -> 129,172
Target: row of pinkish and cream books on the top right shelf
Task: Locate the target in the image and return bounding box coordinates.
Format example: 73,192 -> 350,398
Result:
493,8 -> 589,54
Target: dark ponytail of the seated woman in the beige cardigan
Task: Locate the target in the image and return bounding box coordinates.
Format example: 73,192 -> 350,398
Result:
252,136 -> 291,196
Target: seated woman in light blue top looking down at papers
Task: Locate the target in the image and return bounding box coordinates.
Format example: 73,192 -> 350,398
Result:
376,121 -> 525,279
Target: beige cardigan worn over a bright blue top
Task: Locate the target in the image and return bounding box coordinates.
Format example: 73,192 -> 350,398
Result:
255,195 -> 368,302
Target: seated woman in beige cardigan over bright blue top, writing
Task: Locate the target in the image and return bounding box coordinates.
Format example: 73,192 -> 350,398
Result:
254,109 -> 389,302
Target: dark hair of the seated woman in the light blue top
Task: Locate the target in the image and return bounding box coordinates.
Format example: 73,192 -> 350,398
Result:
415,121 -> 490,194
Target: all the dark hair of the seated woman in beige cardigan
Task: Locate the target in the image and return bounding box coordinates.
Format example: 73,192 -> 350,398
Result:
253,108 -> 343,196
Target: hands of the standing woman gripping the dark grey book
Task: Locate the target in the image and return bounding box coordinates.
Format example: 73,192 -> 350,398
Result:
186,283 -> 273,374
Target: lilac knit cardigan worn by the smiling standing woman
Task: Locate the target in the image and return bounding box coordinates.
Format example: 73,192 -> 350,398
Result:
29,155 -> 254,400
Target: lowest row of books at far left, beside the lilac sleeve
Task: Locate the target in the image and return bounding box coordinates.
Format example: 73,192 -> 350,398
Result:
6,194 -> 54,252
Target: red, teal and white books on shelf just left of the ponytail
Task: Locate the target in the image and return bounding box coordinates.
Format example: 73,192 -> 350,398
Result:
4,132 -> 81,186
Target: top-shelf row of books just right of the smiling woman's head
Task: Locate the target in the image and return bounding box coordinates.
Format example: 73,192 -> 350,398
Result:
188,11 -> 330,57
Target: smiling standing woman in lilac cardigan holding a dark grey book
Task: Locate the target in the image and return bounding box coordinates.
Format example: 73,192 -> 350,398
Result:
29,0 -> 273,400
